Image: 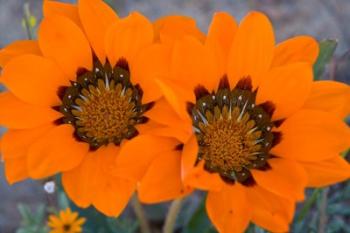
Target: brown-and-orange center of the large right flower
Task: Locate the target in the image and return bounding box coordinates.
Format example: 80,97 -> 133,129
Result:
189,77 -> 278,184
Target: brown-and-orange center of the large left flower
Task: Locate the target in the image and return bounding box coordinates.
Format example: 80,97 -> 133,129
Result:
55,60 -> 152,149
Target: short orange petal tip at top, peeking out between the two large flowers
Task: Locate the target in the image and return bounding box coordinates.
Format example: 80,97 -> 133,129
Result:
154,15 -> 205,46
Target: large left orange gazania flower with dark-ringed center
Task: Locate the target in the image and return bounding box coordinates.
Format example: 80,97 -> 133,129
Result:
0,0 -> 200,216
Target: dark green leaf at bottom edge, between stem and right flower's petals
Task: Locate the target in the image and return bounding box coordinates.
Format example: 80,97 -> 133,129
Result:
183,200 -> 216,233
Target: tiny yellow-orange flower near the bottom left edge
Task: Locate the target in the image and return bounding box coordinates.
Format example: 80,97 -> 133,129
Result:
48,208 -> 85,233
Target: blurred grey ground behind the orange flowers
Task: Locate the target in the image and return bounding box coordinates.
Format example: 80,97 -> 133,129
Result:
0,0 -> 350,233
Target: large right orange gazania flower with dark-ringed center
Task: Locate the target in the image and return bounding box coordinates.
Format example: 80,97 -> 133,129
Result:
146,12 -> 350,233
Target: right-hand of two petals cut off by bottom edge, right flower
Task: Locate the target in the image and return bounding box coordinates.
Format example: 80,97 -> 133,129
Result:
246,185 -> 295,232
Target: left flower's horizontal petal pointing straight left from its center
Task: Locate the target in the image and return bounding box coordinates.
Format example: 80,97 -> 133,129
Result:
0,92 -> 61,129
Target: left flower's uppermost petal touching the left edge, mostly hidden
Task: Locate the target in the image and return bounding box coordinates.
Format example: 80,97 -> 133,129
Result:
0,40 -> 41,67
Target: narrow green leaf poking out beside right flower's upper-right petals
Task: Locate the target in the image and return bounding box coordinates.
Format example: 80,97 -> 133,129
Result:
314,40 -> 338,80
